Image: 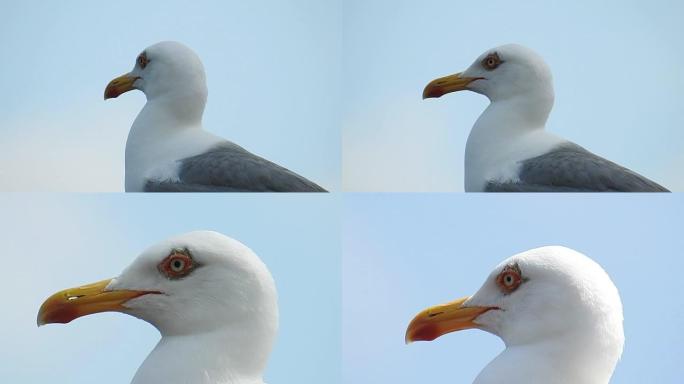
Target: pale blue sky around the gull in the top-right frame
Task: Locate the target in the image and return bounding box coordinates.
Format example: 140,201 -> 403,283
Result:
342,0 -> 684,191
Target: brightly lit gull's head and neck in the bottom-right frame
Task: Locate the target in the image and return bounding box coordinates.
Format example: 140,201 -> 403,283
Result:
405,246 -> 625,384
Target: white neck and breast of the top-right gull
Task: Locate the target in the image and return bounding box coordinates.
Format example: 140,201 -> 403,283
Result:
465,92 -> 563,192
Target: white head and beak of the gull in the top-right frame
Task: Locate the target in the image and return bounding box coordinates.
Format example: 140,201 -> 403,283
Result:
423,44 -> 553,102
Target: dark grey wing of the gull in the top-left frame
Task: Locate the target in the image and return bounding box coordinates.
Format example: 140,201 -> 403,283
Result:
145,142 -> 326,192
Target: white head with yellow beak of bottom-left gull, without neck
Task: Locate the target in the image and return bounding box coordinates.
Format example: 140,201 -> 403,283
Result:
38,231 -> 278,341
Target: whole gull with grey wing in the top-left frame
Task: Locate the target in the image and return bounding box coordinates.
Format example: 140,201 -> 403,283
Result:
104,41 -> 325,192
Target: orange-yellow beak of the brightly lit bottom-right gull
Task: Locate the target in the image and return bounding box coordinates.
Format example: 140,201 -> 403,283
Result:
405,297 -> 497,344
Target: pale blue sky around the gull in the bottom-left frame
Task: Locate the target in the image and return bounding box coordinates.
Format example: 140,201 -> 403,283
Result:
0,194 -> 341,384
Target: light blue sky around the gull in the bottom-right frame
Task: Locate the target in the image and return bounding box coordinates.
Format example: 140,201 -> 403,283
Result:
342,194 -> 684,384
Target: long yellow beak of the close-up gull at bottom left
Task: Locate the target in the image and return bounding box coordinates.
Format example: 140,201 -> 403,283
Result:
38,279 -> 161,326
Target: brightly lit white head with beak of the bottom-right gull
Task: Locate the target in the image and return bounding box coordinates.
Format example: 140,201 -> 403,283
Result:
406,246 -> 624,377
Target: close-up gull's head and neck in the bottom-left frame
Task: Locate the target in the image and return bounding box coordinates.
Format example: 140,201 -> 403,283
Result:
38,231 -> 278,384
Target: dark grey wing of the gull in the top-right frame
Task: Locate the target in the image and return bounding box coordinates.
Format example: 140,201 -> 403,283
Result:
486,143 -> 669,192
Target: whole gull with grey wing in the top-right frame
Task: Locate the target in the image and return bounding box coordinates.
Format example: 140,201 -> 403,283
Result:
423,44 -> 668,192
